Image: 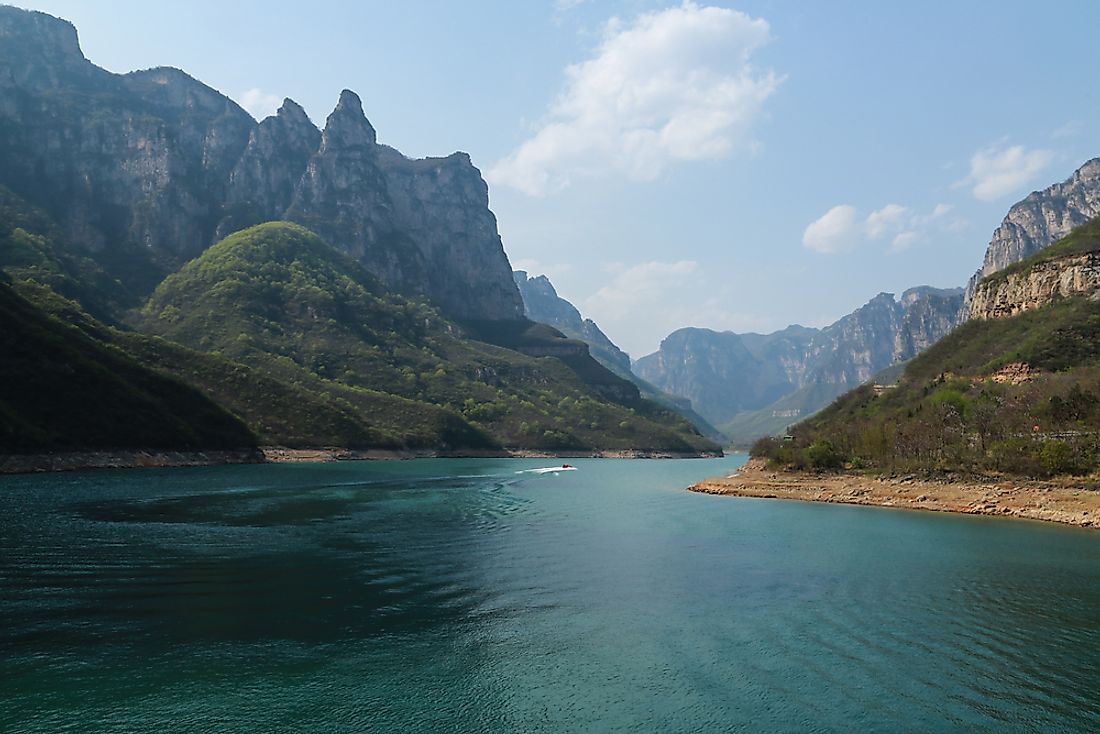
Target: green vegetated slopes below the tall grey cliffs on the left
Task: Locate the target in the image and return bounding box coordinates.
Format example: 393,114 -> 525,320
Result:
0,190 -> 716,452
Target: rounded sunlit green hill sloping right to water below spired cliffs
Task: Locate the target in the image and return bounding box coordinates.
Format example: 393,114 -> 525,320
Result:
134,222 -> 716,452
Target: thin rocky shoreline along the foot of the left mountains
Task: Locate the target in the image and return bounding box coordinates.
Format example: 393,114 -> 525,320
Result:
0,446 -> 723,475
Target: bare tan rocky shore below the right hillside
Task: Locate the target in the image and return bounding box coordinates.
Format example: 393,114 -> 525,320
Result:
688,459 -> 1100,529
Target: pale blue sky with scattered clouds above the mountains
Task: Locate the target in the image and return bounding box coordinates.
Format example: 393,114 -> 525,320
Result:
15,0 -> 1100,359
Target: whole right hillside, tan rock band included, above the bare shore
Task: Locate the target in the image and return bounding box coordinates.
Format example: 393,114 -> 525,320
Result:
754,219 -> 1100,476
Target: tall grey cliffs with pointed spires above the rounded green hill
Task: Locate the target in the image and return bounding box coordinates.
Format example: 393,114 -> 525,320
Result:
0,7 -> 523,319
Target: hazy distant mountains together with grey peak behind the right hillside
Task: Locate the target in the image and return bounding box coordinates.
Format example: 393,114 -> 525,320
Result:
634,158 -> 1100,445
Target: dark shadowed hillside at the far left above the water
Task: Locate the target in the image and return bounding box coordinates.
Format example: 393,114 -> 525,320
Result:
0,275 -> 256,456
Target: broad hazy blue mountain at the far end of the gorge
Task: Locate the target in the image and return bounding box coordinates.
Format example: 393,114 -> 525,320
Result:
635,286 -> 963,442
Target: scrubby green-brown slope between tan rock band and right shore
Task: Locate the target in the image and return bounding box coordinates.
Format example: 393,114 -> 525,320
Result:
758,298 -> 1100,476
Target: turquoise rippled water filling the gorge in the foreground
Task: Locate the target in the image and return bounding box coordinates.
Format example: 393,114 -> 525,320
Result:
0,458 -> 1100,733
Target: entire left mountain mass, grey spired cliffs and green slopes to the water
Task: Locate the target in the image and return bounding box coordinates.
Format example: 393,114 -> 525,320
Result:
0,6 -> 717,462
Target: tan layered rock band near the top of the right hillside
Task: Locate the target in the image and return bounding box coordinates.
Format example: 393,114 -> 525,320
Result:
970,252 -> 1100,319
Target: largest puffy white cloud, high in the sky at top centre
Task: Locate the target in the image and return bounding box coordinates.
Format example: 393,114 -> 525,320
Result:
486,0 -> 780,196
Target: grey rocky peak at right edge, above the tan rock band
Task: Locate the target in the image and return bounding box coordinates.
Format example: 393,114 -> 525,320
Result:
964,158 -> 1100,308
